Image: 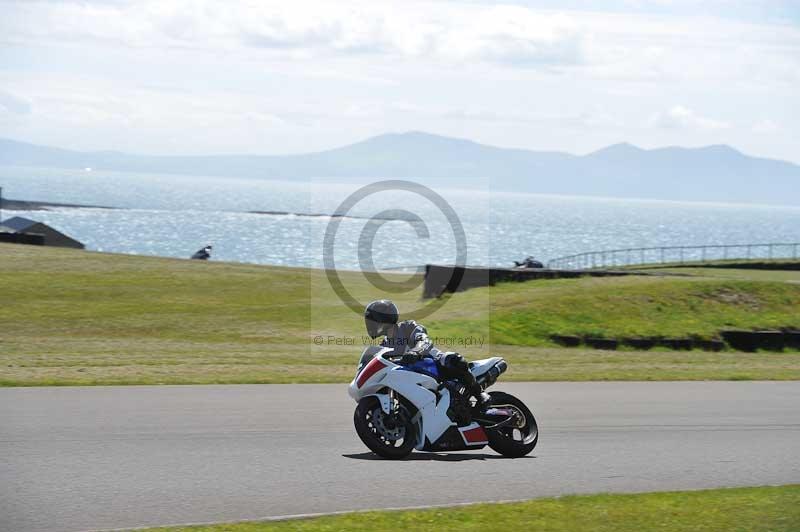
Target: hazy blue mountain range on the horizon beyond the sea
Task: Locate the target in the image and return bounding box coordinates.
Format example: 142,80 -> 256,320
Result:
0,132 -> 800,205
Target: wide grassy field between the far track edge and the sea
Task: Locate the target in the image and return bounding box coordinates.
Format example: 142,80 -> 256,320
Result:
0,244 -> 800,385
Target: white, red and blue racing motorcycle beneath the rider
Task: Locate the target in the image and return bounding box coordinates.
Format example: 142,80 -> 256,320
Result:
348,346 -> 539,459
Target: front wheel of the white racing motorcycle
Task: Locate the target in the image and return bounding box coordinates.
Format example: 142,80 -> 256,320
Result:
353,396 -> 416,460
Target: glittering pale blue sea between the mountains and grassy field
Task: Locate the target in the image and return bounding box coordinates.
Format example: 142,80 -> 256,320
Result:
0,166 -> 800,270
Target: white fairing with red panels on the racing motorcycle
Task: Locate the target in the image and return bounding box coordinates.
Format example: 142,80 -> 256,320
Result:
348,348 -> 488,450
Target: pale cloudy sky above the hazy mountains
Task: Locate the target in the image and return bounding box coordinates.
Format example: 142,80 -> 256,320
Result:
0,0 -> 800,163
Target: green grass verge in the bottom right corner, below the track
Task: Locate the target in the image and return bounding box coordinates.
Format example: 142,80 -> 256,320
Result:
147,485 -> 800,532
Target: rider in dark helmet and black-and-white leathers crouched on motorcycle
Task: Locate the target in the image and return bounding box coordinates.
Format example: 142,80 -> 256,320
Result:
364,299 -> 491,406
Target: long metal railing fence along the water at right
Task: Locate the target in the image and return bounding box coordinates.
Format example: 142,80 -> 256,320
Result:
547,243 -> 800,270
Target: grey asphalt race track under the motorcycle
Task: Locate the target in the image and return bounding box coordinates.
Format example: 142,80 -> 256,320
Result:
0,382 -> 800,531
